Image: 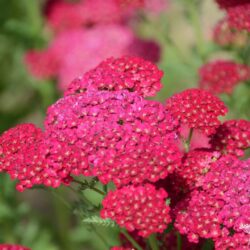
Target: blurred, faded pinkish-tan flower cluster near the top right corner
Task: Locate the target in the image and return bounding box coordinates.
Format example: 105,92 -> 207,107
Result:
213,17 -> 247,47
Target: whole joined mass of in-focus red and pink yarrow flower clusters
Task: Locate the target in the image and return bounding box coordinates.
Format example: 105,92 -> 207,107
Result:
0,56 -> 250,249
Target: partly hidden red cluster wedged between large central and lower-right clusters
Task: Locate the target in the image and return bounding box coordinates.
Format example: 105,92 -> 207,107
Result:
175,149 -> 220,190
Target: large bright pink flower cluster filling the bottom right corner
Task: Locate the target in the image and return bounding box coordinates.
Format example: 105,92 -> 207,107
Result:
175,156 -> 250,249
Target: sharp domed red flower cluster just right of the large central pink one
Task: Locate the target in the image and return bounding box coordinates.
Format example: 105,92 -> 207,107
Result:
166,89 -> 227,135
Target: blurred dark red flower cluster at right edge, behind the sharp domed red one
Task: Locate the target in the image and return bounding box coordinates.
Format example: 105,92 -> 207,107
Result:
199,60 -> 250,94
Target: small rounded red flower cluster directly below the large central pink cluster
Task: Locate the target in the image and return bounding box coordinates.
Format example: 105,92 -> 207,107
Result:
101,184 -> 171,237
